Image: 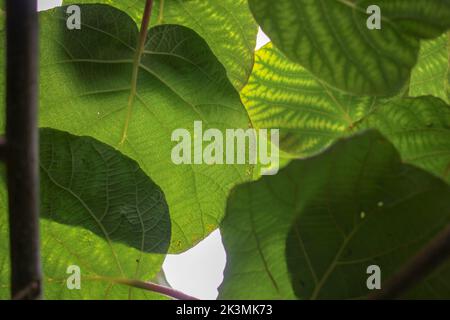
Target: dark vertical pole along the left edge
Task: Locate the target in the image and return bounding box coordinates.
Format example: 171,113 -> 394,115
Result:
6,0 -> 41,299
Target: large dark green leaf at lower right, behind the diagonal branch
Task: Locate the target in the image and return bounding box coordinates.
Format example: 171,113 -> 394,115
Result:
220,131 -> 450,299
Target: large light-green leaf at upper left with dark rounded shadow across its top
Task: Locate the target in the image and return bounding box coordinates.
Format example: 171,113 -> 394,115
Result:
0,5 -> 252,251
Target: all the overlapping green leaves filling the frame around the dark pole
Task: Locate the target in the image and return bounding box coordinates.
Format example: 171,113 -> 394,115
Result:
0,0 -> 450,299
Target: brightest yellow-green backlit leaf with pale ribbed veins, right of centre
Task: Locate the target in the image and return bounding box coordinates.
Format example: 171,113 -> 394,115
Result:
241,43 -> 379,157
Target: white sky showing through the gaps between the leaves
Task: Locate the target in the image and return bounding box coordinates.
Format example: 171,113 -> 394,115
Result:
38,0 -> 270,299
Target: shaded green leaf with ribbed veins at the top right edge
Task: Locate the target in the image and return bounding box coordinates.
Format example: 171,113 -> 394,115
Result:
249,0 -> 450,96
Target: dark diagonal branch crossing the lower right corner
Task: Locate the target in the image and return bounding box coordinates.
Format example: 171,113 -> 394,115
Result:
368,225 -> 450,300
